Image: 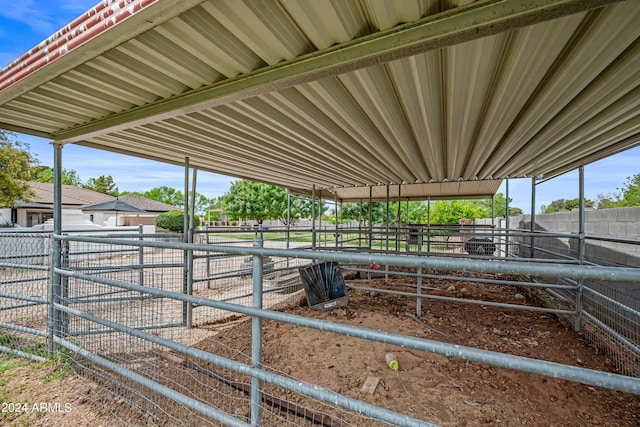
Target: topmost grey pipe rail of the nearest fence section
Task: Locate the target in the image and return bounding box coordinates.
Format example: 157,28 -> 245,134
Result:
53,236 -> 640,283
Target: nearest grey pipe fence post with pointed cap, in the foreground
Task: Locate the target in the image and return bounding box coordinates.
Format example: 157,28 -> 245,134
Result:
251,234 -> 264,426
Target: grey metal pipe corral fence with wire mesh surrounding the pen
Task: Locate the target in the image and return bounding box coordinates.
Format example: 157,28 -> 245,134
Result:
0,225 -> 640,426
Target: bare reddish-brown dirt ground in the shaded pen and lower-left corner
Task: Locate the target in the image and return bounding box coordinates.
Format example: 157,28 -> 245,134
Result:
0,275 -> 640,426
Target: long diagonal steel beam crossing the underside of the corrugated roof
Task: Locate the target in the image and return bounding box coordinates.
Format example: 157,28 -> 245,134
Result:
52,0 -> 619,143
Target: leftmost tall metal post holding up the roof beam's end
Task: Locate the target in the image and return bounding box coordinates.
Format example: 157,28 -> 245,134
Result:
47,142 -> 62,354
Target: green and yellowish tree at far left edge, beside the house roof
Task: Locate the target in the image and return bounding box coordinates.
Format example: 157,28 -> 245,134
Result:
0,130 -> 36,207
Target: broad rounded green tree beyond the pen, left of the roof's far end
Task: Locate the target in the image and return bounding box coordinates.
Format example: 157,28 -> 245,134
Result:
222,179 -> 326,224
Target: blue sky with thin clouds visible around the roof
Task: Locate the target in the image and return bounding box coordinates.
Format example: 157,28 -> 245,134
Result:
0,0 -> 640,213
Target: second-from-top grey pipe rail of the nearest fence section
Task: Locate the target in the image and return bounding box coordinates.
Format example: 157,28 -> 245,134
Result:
54,270 -> 640,394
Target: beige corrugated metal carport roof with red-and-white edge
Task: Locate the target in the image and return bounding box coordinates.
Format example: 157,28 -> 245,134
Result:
0,0 -> 640,200
